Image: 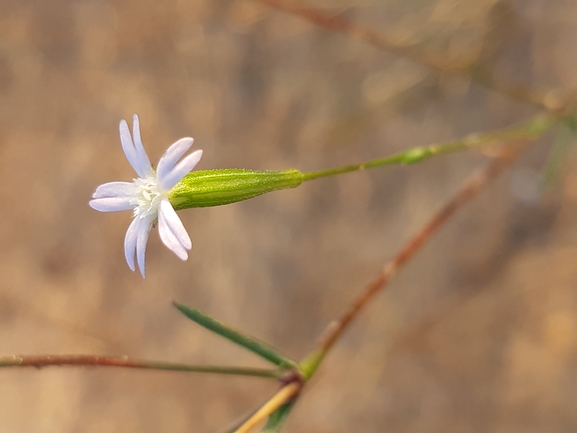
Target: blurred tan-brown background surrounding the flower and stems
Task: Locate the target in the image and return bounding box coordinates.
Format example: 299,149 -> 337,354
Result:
0,0 -> 577,433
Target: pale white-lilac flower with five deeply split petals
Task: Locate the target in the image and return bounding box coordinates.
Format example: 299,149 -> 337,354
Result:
90,114 -> 202,277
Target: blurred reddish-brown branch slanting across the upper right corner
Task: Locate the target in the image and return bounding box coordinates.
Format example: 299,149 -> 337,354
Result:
257,0 -> 572,112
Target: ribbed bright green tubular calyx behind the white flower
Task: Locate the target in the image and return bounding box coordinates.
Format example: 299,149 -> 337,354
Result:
168,168 -> 303,210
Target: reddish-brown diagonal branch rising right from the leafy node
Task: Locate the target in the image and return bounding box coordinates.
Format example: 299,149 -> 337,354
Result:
316,144 -> 523,362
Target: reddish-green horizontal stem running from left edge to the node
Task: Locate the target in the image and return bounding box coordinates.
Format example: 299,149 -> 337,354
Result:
0,355 -> 285,379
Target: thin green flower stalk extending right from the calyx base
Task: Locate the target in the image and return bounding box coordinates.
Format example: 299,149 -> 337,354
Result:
302,115 -> 556,181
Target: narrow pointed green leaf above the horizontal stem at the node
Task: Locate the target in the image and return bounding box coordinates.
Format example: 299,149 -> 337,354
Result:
174,302 -> 298,368
